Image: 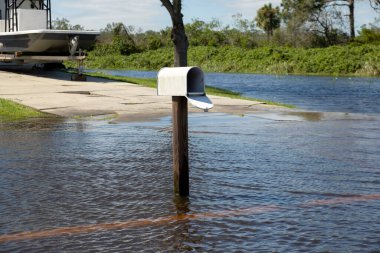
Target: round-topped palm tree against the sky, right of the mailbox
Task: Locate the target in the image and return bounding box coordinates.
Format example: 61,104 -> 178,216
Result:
255,4 -> 281,40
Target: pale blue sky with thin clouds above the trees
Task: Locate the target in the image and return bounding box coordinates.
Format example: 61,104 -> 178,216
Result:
51,0 -> 380,31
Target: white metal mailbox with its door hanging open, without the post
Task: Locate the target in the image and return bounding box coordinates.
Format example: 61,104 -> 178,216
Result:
157,67 -> 214,111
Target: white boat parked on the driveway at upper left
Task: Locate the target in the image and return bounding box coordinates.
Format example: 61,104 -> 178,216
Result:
0,0 -> 99,56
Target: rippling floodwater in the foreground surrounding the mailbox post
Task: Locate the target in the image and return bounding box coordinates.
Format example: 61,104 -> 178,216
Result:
0,72 -> 380,252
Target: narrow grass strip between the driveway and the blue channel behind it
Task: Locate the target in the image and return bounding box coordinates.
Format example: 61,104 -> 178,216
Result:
86,72 -> 295,108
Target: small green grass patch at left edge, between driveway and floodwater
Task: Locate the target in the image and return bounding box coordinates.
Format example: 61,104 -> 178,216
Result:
0,98 -> 48,122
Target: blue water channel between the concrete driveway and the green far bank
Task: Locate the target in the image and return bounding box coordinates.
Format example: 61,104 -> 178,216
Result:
103,70 -> 380,113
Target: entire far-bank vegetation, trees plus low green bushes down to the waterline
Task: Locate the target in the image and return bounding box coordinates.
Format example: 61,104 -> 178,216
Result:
54,0 -> 380,76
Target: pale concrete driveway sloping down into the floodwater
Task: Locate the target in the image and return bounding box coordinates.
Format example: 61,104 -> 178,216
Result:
0,69 -> 278,121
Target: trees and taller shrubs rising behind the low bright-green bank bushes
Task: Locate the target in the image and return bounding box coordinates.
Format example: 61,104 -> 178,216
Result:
53,5 -> 380,55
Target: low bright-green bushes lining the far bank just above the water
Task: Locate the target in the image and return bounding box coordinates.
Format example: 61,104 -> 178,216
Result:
87,44 -> 380,76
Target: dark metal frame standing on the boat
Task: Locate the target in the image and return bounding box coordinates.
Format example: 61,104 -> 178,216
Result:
4,0 -> 52,32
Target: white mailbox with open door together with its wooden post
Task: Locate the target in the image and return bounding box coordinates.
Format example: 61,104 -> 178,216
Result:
157,67 -> 213,196
